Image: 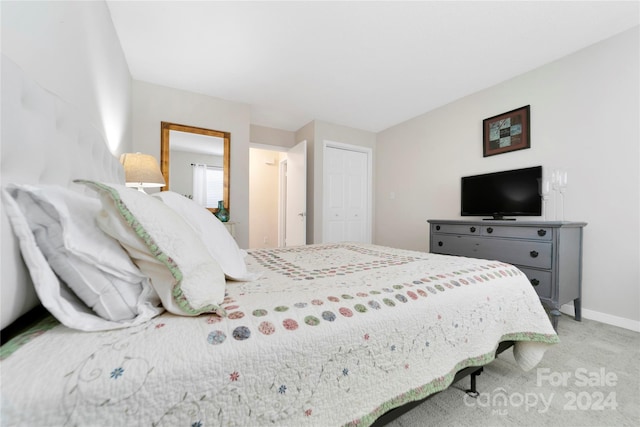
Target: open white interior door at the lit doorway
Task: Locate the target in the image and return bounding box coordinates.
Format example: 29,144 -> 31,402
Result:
285,141 -> 307,246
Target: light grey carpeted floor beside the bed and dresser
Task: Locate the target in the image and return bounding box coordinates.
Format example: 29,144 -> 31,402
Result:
388,315 -> 640,427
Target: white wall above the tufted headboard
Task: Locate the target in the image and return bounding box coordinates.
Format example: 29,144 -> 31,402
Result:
0,1 -> 132,155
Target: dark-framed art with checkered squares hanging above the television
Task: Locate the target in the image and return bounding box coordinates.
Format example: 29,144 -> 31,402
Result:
482,105 -> 531,157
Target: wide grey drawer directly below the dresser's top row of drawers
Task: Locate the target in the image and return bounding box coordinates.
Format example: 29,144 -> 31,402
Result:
431,234 -> 552,268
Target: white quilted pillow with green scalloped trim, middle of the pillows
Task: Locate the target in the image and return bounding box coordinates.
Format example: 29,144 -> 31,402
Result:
75,180 -> 226,316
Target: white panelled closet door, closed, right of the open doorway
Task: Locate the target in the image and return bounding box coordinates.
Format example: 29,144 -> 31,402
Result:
323,146 -> 370,243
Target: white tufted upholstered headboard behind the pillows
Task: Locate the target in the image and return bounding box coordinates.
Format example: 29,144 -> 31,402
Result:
0,55 -> 124,328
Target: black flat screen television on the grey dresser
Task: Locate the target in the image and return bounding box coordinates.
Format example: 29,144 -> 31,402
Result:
461,166 -> 542,220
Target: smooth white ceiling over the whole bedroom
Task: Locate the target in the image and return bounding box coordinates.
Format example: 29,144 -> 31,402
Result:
107,1 -> 639,132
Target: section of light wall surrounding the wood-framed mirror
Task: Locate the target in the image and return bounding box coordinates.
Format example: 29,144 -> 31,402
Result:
133,80 -> 250,248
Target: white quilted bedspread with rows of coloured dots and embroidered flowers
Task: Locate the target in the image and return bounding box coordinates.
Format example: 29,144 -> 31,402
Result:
0,244 -> 557,427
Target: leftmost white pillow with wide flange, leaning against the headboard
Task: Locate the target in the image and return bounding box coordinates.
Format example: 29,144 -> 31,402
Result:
2,184 -> 164,331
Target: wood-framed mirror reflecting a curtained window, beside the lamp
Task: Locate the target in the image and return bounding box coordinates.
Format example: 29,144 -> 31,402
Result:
160,122 -> 231,213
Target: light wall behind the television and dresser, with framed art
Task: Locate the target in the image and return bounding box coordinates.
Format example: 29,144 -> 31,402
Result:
375,27 -> 640,329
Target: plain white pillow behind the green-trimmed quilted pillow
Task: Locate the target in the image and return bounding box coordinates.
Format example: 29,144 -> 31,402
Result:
153,191 -> 259,281
